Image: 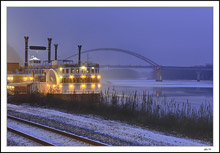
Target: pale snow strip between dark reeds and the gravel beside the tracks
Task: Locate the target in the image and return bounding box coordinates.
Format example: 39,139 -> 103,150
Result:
7,104 -> 212,146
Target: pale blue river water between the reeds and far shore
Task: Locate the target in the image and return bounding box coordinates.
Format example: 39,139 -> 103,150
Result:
101,79 -> 213,107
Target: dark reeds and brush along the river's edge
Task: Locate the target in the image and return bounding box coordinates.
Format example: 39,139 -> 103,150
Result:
8,89 -> 213,142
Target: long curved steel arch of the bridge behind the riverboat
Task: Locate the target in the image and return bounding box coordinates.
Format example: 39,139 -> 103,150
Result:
65,48 -> 159,67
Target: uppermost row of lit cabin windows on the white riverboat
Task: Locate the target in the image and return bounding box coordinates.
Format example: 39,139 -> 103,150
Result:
60,68 -> 99,74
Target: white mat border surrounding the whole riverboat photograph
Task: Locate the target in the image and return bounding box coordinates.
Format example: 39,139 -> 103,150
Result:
1,1 -> 219,152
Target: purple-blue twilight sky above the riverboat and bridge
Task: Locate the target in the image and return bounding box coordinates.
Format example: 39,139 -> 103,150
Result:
7,7 -> 213,66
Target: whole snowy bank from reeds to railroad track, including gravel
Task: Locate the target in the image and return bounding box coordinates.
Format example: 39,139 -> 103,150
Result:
7,104 -> 212,146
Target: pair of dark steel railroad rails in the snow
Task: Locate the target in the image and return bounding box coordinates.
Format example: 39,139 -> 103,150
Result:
7,115 -> 107,146
